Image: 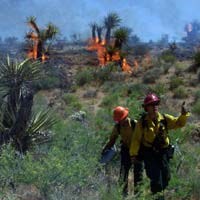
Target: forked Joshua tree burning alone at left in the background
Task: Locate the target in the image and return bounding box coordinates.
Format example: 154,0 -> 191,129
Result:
26,16 -> 58,59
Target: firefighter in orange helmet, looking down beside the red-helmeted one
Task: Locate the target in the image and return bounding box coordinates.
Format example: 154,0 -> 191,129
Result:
102,106 -> 143,196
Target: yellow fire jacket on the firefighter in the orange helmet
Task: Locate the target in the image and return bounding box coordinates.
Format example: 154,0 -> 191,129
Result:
106,118 -> 136,148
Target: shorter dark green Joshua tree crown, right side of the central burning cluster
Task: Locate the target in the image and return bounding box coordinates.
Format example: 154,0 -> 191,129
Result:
114,27 -> 131,50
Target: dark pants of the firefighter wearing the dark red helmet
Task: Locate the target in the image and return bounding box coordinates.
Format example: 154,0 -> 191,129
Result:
143,148 -> 170,194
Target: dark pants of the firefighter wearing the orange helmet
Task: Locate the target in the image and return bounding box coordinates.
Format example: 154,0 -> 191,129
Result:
120,145 -> 144,194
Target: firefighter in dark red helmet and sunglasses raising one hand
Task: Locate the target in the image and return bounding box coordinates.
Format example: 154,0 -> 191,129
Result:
130,93 -> 189,199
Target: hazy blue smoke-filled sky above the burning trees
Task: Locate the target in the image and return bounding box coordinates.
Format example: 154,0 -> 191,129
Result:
0,0 -> 200,41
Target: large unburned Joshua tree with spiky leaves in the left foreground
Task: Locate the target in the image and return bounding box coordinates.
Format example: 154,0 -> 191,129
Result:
0,58 -> 54,153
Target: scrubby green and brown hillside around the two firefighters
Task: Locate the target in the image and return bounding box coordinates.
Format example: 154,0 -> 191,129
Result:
0,47 -> 200,200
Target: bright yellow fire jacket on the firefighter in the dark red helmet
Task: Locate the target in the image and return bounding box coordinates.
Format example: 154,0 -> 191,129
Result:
130,113 -> 190,156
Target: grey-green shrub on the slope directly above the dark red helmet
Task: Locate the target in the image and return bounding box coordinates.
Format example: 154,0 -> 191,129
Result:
143,68 -> 162,83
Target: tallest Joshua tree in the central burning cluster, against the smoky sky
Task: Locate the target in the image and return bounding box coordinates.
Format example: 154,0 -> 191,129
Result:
104,13 -> 121,44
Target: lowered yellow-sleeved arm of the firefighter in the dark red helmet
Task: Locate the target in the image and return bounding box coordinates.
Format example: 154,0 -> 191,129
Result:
130,122 -> 142,157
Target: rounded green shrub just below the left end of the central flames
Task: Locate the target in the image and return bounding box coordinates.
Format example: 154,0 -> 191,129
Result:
75,69 -> 94,86
